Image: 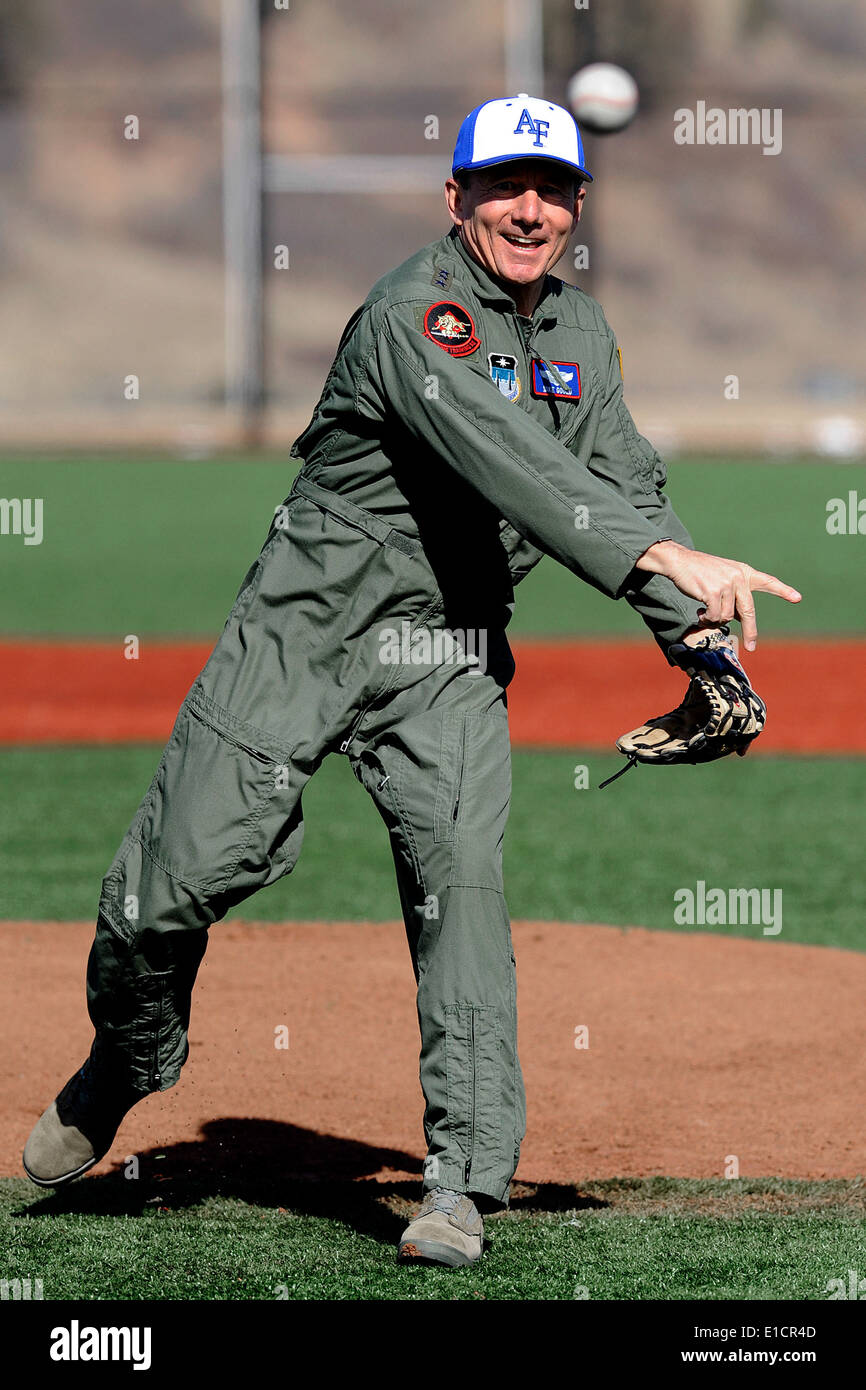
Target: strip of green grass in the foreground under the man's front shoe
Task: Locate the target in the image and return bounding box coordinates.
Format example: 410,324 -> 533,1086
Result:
0,1166 -> 866,1301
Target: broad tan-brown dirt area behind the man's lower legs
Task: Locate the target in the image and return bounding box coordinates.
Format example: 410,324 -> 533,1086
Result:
0,922 -> 866,1183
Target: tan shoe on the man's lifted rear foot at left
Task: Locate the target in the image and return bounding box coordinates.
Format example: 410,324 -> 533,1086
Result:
22,1062 -> 140,1187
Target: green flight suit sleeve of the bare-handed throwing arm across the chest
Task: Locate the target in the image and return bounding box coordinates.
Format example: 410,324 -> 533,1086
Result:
356,300 -> 681,598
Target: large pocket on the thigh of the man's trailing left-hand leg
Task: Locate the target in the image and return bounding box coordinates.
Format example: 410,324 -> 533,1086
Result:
140,687 -> 289,892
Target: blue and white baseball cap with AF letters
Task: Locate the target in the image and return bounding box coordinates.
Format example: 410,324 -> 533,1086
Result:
452,92 -> 592,182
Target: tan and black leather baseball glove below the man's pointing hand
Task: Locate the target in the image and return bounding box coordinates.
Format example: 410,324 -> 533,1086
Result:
601,631 -> 767,787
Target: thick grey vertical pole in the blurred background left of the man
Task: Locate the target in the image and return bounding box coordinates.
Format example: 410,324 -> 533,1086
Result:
222,0 -> 264,443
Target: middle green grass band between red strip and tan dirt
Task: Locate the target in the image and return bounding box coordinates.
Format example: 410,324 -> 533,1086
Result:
0,746 -> 866,951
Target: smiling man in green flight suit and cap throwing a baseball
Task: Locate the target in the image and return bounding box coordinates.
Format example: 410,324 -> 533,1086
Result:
24,95 -> 799,1265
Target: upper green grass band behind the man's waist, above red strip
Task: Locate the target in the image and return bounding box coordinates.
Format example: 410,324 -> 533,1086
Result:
0,449 -> 866,637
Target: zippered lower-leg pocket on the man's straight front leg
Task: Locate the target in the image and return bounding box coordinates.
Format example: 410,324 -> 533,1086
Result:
445,1004 -> 502,1182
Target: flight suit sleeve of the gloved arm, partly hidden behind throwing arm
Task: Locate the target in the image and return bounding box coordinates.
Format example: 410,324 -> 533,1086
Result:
589,329 -> 699,652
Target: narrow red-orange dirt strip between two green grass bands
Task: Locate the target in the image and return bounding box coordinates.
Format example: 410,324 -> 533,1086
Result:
0,639 -> 866,755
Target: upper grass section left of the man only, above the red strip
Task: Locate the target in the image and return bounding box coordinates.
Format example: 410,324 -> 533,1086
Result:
0,450 -> 296,637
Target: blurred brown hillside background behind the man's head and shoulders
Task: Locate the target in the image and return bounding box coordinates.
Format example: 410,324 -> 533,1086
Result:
0,0 -> 866,457
